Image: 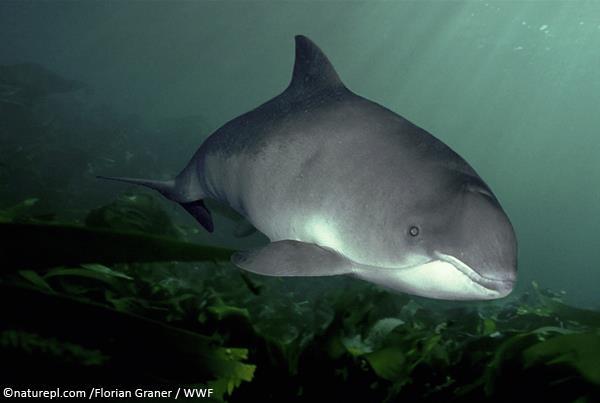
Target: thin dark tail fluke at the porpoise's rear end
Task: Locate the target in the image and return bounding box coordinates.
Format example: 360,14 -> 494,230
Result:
98,176 -> 214,232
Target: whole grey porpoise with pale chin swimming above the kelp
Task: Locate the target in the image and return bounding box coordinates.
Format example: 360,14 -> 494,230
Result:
101,36 -> 517,300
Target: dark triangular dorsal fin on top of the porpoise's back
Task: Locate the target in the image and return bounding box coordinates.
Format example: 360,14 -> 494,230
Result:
286,35 -> 344,95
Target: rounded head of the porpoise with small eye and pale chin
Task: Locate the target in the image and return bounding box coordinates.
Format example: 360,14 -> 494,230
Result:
358,172 -> 517,300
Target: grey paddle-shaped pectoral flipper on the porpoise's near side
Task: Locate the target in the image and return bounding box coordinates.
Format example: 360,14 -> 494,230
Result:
231,240 -> 352,276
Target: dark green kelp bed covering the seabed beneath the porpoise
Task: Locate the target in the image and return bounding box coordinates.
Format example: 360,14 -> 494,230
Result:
0,200 -> 600,402
